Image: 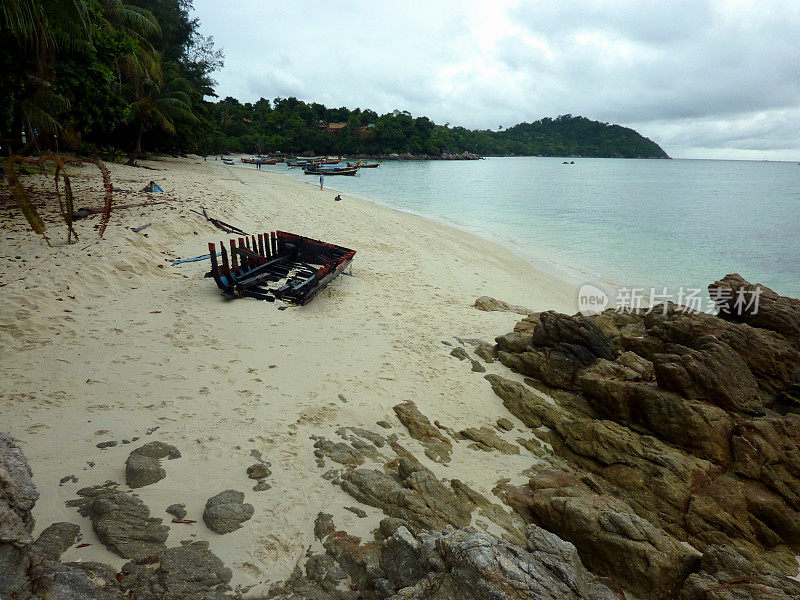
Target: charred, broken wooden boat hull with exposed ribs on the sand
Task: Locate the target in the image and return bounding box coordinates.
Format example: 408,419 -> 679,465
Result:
206,231 -> 356,305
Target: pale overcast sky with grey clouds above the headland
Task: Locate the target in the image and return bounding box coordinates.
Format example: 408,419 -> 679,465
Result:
194,0 -> 800,160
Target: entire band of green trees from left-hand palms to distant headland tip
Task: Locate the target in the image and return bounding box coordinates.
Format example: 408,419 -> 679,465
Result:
0,0 -> 667,163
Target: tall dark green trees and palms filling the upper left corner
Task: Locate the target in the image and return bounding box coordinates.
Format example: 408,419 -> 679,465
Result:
0,0 -> 216,154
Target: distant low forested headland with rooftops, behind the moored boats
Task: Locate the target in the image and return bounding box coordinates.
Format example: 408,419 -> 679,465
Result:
212,97 -> 669,158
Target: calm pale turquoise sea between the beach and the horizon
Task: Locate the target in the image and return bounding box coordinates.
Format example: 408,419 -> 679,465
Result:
260,158 -> 800,297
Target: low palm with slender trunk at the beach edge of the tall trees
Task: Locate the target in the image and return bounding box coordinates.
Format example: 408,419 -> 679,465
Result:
126,70 -> 197,165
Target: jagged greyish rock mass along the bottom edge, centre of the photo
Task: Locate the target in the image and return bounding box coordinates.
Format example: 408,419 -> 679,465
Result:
269,519 -> 617,600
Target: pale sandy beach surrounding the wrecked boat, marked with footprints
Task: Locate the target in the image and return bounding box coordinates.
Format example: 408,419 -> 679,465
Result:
0,159 -> 575,591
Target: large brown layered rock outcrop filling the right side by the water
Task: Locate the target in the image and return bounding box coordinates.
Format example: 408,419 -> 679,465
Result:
487,275 -> 800,600
